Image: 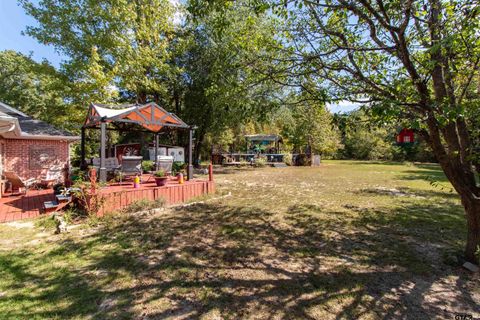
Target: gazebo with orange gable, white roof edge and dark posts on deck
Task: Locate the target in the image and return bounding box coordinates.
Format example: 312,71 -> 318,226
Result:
81,102 -> 194,182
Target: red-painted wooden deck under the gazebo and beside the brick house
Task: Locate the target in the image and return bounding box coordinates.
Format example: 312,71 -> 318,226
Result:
0,176 -> 215,223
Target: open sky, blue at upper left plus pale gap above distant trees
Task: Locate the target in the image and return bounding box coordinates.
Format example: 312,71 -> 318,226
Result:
0,0 -> 358,113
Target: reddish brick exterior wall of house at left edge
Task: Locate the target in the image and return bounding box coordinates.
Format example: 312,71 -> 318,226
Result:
0,139 -> 70,179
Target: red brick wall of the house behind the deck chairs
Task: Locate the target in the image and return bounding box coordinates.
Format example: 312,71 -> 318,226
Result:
0,139 -> 70,179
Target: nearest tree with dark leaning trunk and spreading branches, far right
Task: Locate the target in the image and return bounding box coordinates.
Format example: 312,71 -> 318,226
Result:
266,0 -> 480,261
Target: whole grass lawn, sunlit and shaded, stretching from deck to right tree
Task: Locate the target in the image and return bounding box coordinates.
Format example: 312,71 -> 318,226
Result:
0,161 -> 480,319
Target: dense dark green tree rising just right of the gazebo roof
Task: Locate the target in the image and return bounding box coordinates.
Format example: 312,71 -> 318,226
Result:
181,3 -> 282,162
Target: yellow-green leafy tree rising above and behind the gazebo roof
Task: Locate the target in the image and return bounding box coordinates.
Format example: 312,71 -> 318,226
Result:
20,0 -> 177,104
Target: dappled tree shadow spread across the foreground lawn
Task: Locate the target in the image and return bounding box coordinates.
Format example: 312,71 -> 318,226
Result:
0,200 -> 478,319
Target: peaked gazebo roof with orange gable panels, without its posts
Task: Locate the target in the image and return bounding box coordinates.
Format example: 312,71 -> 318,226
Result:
84,102 -> 189,132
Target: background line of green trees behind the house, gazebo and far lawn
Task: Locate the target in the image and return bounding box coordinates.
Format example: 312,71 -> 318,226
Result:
0,0 -> 431,164
